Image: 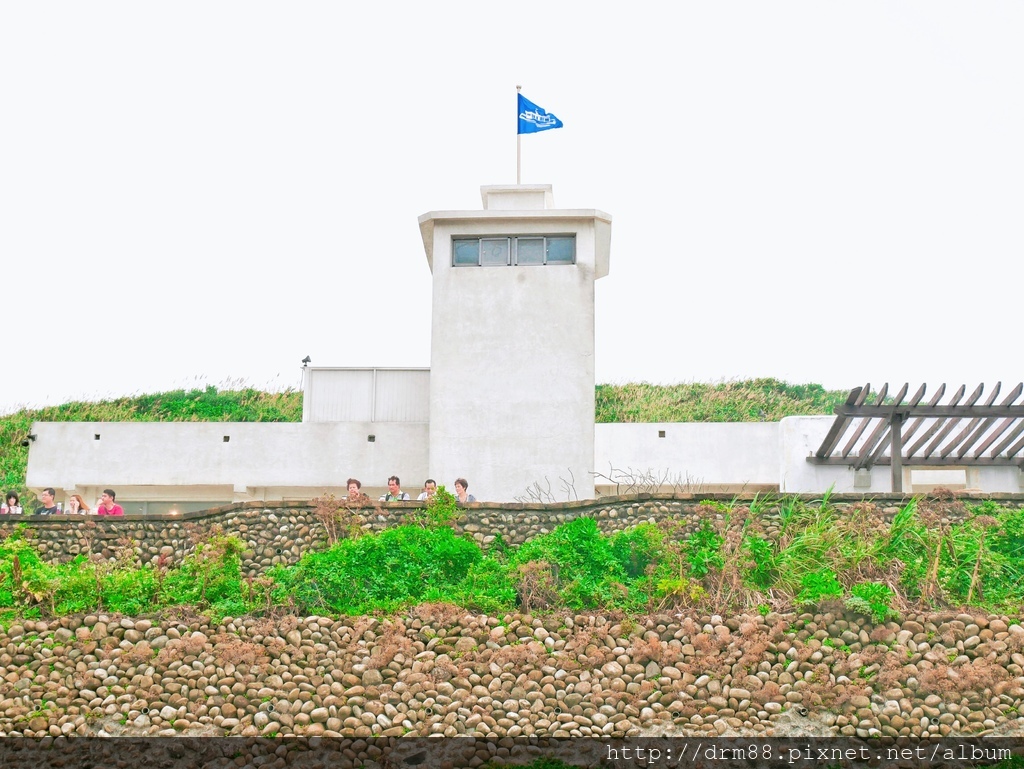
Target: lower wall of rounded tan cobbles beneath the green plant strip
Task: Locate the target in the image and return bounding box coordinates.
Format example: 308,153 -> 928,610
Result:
0,605 -> 1024,745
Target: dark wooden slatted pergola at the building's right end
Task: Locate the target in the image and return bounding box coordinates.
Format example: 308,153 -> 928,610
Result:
807,382 -> 1024,493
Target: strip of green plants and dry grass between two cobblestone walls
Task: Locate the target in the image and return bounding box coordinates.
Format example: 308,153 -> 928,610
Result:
0,488 -> 1024,625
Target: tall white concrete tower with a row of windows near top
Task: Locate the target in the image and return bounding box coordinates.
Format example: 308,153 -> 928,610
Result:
420,184 -> 611,502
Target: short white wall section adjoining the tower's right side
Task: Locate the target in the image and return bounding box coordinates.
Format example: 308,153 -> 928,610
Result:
594,422 -> 780,492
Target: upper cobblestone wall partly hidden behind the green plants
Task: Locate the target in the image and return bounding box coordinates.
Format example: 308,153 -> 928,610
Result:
0,494 -> 1024,576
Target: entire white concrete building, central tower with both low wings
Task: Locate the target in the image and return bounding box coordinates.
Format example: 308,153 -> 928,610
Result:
27,185 -> 1024,513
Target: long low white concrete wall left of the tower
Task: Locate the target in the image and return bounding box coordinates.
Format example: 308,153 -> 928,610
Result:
27,422 -> 428,504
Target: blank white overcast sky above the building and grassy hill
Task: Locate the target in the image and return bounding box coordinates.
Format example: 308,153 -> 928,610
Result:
0,0 -> 1024,411
